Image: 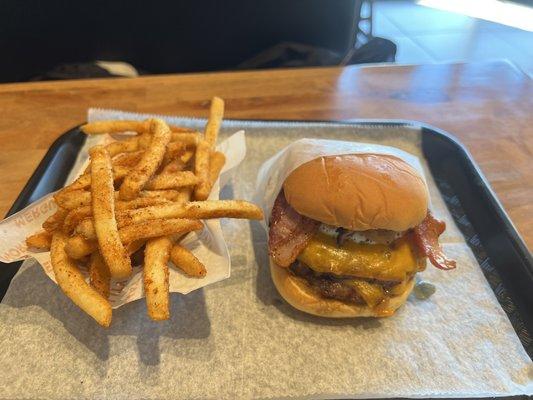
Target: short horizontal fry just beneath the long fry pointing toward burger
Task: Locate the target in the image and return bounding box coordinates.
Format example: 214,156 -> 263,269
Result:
118,218 -> 203,244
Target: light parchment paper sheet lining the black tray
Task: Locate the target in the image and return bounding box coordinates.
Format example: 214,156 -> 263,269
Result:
0,112 -> 533,399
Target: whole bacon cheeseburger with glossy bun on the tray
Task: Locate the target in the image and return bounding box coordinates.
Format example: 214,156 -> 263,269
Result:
269,154 -> 455,318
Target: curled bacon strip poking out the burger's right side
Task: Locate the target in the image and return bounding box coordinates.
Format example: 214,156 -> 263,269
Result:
413,212 -> 456,270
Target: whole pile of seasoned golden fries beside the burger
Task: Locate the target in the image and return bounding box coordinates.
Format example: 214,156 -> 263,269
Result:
26,97 -> 263,327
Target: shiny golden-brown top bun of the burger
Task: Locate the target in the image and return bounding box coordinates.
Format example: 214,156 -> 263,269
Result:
283,154 -> 429,231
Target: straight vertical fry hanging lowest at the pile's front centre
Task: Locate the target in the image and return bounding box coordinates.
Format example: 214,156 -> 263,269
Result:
143,237 -> 172,321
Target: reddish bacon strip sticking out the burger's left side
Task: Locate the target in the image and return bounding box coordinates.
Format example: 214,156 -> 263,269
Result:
268,191 -> 320,267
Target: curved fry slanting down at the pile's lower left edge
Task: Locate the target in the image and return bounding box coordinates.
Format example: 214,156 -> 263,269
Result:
50,232 -> 112,327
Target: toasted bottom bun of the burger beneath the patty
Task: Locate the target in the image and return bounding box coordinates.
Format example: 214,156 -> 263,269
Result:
270,259 -> 415,318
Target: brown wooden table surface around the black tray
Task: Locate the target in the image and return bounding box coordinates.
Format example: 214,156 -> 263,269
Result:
0,62 -> 533,249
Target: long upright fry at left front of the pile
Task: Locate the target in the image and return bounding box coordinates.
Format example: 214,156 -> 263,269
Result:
89,146 -> 131,278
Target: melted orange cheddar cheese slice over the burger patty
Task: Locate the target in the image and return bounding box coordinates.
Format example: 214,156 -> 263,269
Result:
298,232 -> 425,282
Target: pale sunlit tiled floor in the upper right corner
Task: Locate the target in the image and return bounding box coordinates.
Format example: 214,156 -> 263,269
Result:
373,0 -> 533,76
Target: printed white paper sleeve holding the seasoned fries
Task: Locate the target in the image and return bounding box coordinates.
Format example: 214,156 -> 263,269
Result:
0,127 -> 246,308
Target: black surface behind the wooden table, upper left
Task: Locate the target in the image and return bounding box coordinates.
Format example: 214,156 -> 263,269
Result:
0,0 -> 356,82
